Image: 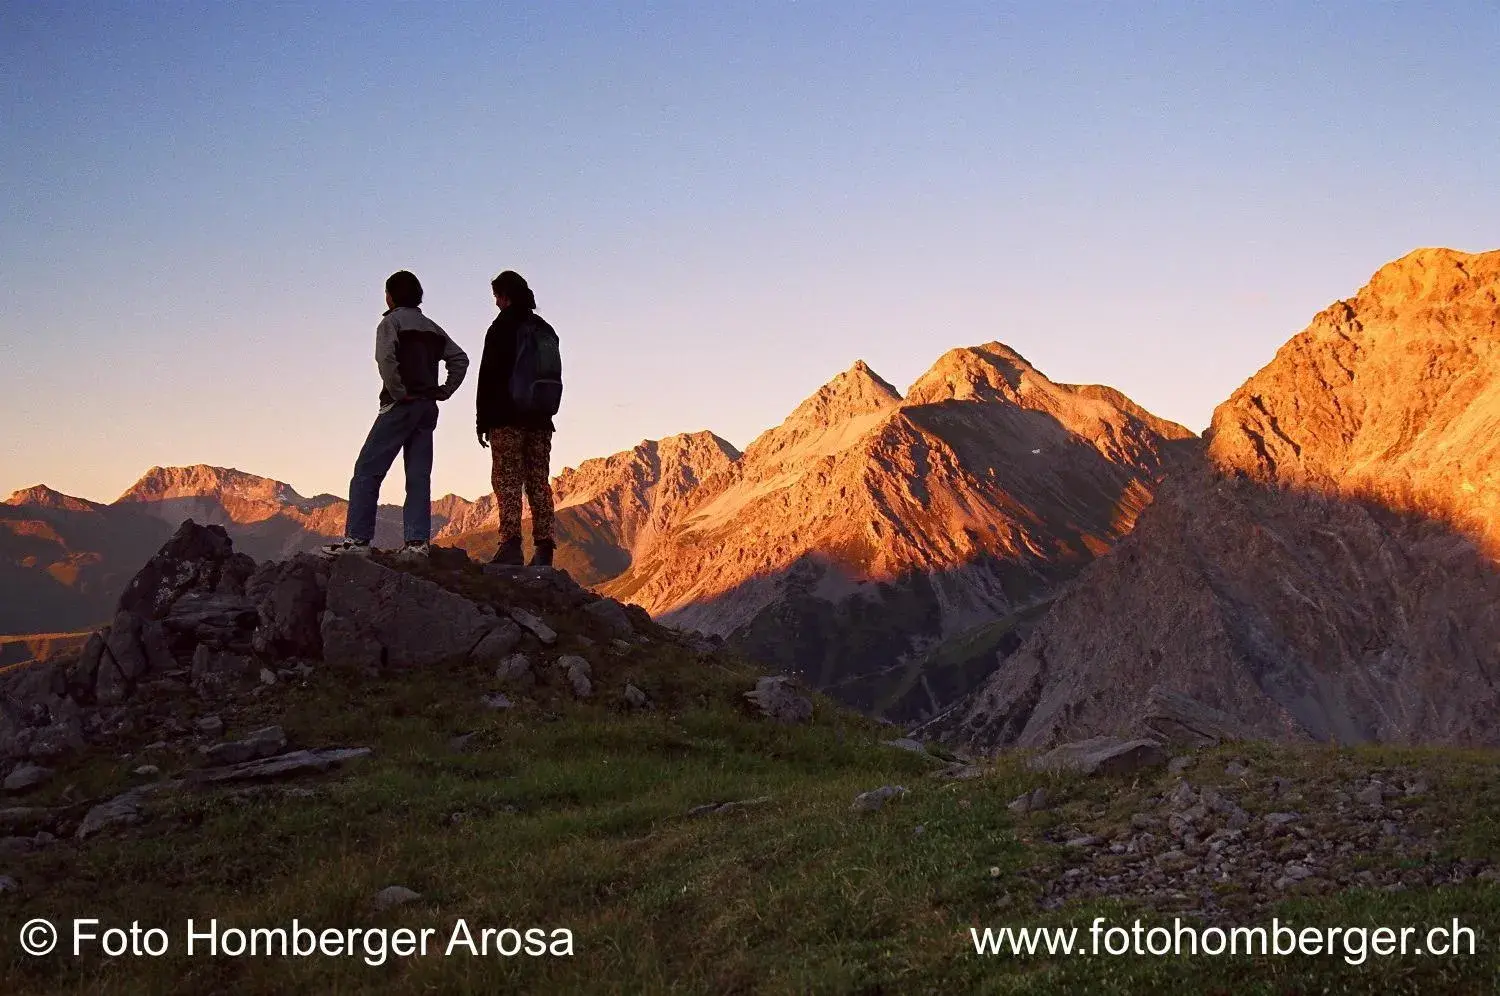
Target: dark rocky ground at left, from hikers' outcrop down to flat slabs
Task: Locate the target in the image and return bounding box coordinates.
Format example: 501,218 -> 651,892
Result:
0,521 -> 726,864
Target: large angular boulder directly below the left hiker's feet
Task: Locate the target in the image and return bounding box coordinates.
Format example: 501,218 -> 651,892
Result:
323,557 -> 495,668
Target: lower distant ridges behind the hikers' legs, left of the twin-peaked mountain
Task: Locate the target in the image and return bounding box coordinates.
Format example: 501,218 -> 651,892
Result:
0,432 -> 738,633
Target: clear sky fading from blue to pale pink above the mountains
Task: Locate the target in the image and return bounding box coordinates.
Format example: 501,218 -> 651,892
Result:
0,0 -> 1500,500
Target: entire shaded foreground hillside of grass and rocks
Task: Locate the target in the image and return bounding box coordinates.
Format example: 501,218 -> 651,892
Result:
0,527 -> 1500,993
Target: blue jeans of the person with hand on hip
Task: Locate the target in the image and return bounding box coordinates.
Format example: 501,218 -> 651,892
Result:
344,398 -> 438,543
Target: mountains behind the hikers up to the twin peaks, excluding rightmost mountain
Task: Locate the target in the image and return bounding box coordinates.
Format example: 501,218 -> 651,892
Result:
3,342 -> 1194,719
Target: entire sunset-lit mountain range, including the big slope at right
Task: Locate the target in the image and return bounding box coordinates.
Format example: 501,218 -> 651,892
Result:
11,249 -> 1500,747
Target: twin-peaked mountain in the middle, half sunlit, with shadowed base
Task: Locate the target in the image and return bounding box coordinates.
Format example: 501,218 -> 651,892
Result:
603,342 -> 1196,716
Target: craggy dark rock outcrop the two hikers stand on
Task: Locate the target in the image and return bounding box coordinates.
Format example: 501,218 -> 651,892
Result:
0,521 -> 669,765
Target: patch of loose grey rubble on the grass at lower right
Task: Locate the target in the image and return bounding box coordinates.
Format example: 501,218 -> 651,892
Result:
1013,755 -> 1500,923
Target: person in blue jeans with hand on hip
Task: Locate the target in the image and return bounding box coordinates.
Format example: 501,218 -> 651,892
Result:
321,270 -> 468,560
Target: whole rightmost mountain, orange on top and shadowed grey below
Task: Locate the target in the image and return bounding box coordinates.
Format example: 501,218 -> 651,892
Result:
935,249 -> 1500,747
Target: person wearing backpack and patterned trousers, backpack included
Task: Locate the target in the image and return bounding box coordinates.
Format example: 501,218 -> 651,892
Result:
474,270 -> 563,567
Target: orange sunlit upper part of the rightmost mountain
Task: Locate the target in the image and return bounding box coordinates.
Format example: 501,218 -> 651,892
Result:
1208,249 -> 1500,551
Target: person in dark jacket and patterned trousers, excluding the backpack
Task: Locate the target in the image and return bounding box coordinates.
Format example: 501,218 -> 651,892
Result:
474,270 -> 557,567
